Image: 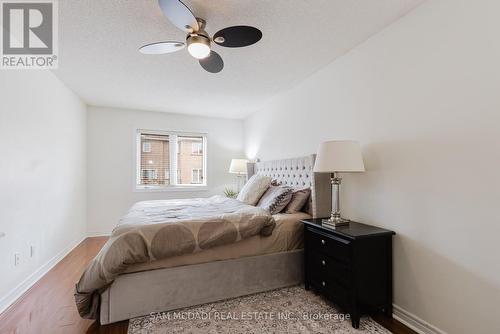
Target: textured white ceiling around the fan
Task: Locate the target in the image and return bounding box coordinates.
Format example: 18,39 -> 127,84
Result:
54,0 -> 422,118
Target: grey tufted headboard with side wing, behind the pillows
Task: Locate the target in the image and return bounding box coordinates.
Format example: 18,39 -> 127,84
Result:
247,154 -> 332,218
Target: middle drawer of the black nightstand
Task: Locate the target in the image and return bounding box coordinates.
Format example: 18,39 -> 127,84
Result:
307,250 -> 351,287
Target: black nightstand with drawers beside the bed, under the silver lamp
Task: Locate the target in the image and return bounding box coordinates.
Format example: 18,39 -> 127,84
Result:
302,219 -> 395,328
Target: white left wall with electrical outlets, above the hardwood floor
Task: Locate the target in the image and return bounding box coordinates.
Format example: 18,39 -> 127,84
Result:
0,70 -> 86,312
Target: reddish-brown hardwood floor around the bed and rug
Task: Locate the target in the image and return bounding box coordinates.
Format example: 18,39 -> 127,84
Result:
0,237 -> 416,334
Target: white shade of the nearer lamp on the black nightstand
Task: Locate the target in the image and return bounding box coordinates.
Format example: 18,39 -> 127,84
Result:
314,140 -> 365,173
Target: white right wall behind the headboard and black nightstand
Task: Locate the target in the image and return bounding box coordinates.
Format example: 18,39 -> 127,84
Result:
245,0 -> 500,334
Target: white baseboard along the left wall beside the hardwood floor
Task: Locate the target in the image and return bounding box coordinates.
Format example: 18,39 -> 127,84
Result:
0,236 -> 87,314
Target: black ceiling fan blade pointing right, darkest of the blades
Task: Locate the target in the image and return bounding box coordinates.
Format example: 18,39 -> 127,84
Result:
213,26 -> 262,48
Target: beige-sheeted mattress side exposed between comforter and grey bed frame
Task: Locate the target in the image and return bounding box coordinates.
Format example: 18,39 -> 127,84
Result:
124,212 -> 311,273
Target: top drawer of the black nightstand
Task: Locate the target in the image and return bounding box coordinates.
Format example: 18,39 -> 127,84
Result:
306,228 -> 351,263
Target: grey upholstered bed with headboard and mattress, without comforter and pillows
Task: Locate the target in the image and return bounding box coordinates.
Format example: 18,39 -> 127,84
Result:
80,155 -> 331,324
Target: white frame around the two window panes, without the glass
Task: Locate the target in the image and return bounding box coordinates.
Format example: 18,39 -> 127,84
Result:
133,129 -> 208,192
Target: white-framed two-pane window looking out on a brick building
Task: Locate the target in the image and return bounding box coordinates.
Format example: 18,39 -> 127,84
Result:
136,130 -> 207,189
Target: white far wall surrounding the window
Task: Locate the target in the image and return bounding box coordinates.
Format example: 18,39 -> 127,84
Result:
87,107 -> 244,235
